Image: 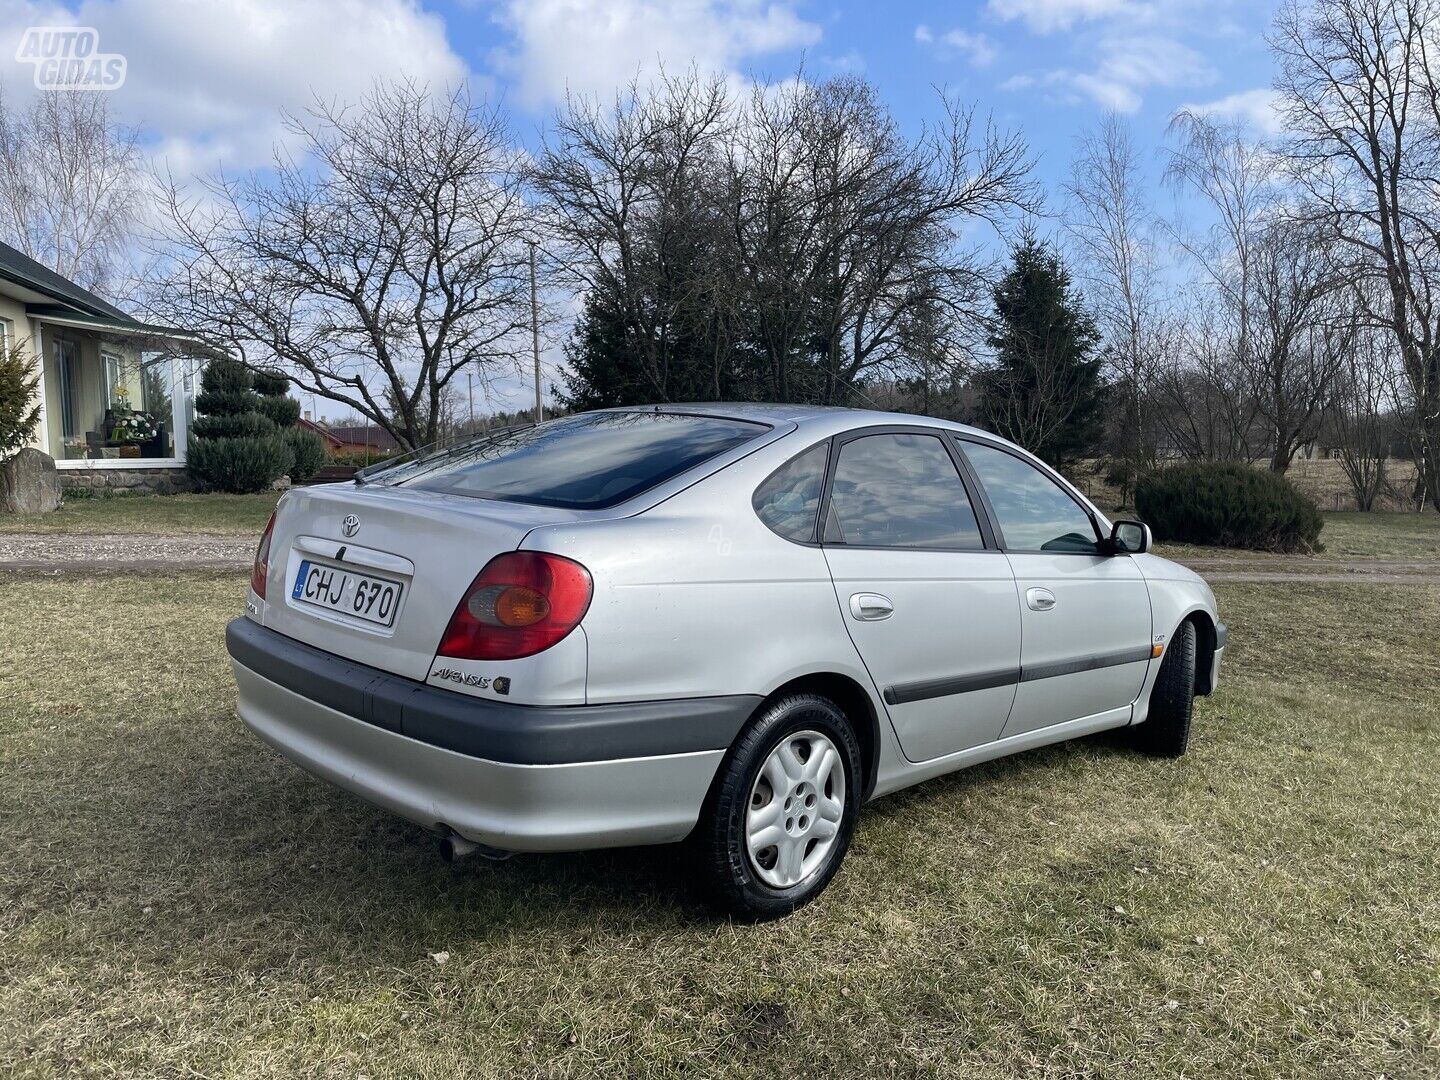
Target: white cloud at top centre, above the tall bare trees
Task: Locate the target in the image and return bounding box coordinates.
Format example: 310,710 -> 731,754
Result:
491,0 -> 821,107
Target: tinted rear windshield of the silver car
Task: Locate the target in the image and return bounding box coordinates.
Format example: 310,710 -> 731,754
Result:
373,412 -> 769,510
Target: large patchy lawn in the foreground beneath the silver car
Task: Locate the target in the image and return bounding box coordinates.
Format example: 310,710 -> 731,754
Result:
0,575 -> 1440,1077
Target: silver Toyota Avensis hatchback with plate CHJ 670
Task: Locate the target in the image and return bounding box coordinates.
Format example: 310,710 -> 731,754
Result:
226,405 -> 1225,917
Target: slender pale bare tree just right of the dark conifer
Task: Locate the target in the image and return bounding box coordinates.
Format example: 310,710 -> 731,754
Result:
1066,114 -> 1171,503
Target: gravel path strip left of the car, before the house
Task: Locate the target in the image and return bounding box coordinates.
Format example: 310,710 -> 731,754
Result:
0,533 -> 255,573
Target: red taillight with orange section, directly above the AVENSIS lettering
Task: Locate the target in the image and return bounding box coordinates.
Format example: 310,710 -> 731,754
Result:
439,552 -> 593,660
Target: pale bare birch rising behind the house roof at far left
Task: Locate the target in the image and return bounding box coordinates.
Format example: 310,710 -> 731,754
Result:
0,89 -> 148,294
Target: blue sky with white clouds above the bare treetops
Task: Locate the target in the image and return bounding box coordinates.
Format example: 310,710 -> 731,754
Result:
0,0 -> 1274,405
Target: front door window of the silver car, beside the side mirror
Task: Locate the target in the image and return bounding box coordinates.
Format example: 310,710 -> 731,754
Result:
962,442 -> 1100,554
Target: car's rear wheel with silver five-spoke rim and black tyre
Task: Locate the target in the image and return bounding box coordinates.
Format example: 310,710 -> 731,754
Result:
696,694 -> 863,922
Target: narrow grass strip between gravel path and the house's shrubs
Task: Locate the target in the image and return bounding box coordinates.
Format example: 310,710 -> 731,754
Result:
0,491 -> 279,537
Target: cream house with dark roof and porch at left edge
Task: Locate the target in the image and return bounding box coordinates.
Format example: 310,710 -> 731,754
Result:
0,243 -> 204,490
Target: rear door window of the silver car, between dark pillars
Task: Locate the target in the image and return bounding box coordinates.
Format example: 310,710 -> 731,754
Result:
825,433 -> 985,549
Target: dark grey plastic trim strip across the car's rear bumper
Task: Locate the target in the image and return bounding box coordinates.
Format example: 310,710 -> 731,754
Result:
225,618 -> 762,765
